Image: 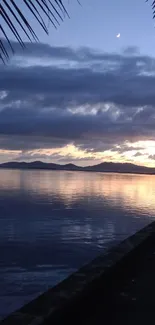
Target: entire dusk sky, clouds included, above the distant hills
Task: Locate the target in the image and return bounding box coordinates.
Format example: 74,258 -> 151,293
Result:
0,0 -> 155,167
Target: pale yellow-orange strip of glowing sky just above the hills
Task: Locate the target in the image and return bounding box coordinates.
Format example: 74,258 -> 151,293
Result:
0,141 -> 155,167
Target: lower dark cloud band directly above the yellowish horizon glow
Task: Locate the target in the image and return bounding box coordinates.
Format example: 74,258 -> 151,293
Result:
0,102 -> 154,152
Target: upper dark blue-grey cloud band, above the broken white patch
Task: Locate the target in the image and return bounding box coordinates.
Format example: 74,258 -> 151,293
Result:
0,44 -> 155,107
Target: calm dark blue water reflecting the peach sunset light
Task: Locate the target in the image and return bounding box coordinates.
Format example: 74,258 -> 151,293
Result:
0,170 -> 155,318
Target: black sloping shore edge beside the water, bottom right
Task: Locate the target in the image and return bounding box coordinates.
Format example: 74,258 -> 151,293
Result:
0,222 -> 155,325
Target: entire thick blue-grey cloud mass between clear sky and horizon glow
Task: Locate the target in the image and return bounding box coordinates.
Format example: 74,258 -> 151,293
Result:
0,44 -> 155,152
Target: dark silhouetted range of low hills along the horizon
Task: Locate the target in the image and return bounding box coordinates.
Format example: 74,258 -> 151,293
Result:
0,161 -> 155,174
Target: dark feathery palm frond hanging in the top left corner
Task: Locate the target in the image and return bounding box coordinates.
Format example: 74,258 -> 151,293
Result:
0,0 -> 69,63
